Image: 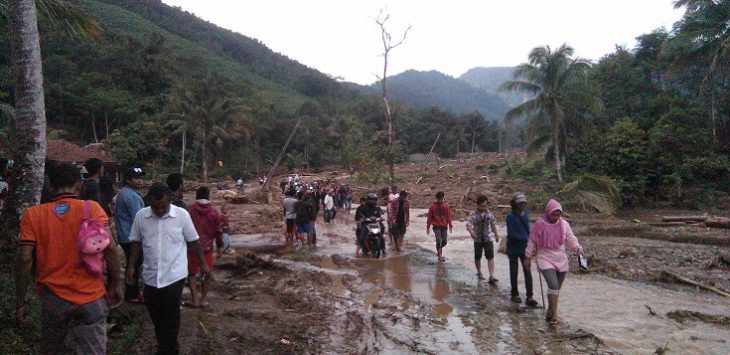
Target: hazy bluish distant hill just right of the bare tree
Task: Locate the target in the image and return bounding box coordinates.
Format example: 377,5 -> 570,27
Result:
368,70 -> 509,120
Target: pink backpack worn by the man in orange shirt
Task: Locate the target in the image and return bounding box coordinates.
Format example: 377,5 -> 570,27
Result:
77,200 -> 110,278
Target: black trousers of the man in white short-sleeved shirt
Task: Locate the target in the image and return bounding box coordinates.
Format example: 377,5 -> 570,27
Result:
144,279 -> 185,355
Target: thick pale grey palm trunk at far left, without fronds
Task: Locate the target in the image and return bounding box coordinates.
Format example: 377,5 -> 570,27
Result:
7,0 -> 46,206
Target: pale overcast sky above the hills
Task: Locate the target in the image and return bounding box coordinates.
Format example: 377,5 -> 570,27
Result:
158,0 -> 683,84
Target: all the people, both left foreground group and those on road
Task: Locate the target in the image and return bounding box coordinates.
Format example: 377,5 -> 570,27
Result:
12,159 -> 582,354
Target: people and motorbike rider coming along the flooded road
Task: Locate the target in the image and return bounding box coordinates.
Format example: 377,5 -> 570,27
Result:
282,182 -> 582,323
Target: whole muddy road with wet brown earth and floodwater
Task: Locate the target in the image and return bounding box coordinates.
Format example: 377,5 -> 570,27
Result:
116,209 -> 730,354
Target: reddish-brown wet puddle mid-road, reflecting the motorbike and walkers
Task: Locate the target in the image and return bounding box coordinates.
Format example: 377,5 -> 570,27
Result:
272,211 -> 605,354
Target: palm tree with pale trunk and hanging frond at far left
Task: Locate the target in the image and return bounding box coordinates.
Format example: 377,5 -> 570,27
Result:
0,0 -> 101,206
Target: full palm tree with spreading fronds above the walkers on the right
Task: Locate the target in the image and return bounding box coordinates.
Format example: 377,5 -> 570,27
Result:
500,44 -> 590,183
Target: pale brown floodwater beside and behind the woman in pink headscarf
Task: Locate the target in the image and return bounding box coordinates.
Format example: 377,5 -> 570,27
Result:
407,209 -> 730,354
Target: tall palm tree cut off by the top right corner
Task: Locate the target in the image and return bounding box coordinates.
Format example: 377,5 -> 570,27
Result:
674,0 -> 730,145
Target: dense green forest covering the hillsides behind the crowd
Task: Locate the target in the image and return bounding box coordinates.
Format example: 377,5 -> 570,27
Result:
0,0 -> 730,209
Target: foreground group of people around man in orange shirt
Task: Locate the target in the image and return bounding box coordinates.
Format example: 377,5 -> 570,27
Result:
16,163 -> 230,354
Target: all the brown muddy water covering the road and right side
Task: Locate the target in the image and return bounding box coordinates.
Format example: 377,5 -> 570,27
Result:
233,209 -> 730,354
